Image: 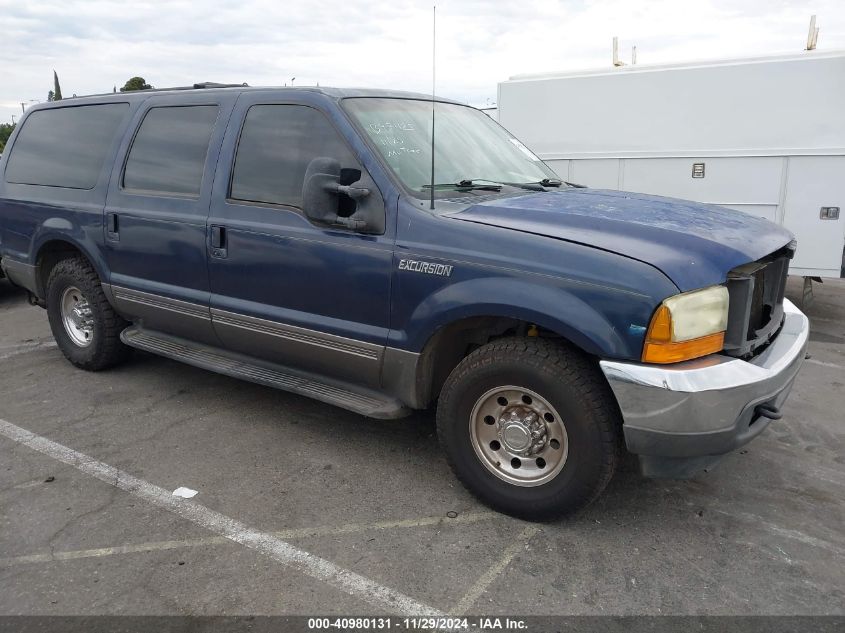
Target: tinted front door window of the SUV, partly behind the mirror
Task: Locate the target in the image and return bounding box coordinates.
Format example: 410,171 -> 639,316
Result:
229,105 -> 358,208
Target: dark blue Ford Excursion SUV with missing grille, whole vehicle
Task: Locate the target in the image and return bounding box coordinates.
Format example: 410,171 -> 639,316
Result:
0,85 -> 808,518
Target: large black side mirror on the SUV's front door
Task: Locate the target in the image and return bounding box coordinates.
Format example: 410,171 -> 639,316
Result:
302,157 -> 370,231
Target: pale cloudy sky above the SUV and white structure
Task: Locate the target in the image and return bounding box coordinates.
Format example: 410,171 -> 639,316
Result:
0,0 -> 845,122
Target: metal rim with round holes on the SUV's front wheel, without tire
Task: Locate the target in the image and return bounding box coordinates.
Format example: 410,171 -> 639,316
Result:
469,386 -> 569,486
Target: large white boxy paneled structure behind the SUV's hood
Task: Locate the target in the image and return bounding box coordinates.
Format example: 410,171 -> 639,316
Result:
497,51 -> 845,277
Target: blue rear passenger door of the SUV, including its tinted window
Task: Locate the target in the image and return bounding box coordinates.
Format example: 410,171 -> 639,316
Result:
104,90 -> 237,343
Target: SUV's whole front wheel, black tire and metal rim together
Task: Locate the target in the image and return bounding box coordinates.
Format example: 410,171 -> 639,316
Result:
437,338 -> 620,519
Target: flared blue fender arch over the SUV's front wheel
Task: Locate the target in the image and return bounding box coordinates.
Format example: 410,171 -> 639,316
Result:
394,276 -> 654,358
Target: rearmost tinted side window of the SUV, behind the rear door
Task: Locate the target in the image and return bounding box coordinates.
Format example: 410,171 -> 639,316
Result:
6,103 -> 129,189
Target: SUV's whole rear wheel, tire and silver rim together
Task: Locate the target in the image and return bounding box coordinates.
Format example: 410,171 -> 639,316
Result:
47,257 -> 129,371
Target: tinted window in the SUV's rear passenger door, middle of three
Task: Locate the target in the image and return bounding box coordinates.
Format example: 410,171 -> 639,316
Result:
123,106 -> 217,196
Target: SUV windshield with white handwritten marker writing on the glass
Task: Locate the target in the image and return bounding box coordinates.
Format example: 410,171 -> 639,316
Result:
343,98 -> 559,198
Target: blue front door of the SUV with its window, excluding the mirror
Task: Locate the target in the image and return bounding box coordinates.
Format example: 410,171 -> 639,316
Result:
204,93 -> 393,385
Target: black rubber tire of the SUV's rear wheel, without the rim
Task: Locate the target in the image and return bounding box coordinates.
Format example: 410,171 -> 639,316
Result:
47,257 -> 129,371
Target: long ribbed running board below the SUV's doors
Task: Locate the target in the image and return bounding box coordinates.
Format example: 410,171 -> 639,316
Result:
120,326 -> 410,419
